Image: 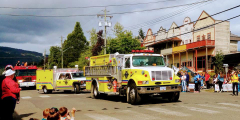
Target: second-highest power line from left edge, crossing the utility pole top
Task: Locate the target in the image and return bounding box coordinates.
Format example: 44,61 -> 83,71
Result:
0,0 -> 212,17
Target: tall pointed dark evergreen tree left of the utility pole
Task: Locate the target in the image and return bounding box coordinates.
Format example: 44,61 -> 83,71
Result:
63,22 -> 89,67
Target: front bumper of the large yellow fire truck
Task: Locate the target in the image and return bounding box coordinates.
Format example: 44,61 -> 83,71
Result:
137,85 -> 182,94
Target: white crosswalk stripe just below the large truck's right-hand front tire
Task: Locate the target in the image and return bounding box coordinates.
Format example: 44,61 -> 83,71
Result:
146,108 -> 191,117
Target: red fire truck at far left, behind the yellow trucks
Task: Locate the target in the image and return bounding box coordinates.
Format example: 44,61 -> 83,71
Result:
14,66 -> 37,87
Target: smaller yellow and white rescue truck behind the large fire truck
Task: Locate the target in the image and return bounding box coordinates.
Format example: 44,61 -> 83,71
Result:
36,67 -> 86,93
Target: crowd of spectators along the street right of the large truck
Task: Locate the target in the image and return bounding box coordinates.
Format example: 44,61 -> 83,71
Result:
179,70 -> 240,96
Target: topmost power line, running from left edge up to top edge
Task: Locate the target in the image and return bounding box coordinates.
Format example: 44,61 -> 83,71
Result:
0,0 -> 176,10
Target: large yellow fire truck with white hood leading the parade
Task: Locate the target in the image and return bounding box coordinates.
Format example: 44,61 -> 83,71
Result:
85,50 -> 181,104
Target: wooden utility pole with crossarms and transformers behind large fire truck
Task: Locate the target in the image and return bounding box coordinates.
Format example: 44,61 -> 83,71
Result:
97,7 -> 113,54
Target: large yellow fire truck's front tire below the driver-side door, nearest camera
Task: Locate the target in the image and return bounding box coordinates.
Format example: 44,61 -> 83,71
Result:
127,83 -> 141,105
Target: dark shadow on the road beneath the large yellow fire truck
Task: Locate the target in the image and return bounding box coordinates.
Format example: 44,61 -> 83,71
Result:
88,95 -> 182,105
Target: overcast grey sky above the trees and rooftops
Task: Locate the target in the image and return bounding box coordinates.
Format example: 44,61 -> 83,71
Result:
0,0 -> 240,53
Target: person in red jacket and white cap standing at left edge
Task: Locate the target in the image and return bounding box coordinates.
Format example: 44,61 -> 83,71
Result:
1,69 -> 21,120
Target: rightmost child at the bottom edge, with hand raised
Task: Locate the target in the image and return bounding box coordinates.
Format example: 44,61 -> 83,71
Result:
59,107 -> 76,120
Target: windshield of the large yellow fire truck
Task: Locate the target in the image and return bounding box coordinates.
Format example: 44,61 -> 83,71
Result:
132,56 -> 165,67
